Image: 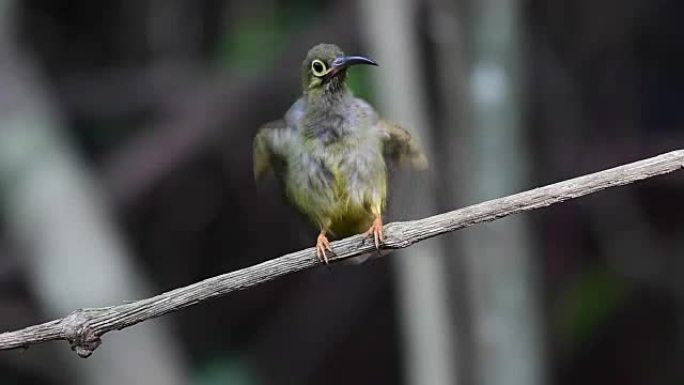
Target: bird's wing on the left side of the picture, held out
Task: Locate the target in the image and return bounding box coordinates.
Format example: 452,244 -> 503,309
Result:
252,120 -> 293,181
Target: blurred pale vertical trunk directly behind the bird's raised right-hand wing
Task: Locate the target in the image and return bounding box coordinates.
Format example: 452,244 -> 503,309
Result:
358,0 -> 462,385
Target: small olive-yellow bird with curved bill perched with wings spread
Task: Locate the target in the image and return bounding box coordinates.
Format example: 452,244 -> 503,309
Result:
253,44 -> 427,264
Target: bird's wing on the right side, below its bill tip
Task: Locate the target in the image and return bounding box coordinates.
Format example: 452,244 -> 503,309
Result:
377,119 -> 428,170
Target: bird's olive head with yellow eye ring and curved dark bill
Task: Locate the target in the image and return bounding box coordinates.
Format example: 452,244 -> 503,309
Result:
302,44 -> 378,94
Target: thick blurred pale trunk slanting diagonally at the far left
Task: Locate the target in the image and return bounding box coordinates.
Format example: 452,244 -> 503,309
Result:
0,1 -> 187,385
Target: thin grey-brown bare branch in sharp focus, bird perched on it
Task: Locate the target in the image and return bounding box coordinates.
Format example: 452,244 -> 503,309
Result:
0,150 -> 684,357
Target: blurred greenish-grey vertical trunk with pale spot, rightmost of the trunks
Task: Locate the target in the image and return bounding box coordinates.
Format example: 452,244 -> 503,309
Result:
462,0 -> 545,385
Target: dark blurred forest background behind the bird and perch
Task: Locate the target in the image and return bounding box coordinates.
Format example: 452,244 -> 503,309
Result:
0,0 -> 684,385
